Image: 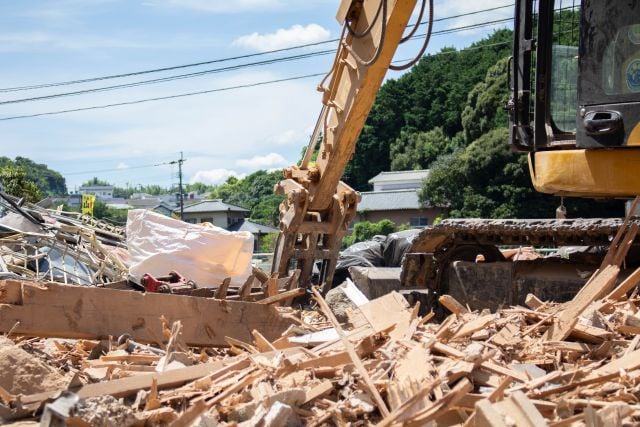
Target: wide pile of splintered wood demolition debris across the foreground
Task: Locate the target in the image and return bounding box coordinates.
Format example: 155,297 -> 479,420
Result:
0,193 -> 640,426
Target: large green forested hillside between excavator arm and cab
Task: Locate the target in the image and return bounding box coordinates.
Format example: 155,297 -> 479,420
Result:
344,29 -> 624,218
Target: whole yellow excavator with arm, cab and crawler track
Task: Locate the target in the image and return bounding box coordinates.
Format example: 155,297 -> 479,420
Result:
272,0 -> 640,309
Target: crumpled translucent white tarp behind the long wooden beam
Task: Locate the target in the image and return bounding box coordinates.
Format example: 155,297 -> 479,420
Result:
127,209 -> 253,287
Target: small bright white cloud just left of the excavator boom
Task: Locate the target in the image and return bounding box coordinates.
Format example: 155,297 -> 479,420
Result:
233,24 -> 331,52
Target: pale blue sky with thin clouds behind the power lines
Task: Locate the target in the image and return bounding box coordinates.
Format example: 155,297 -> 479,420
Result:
0,0 -> 512,190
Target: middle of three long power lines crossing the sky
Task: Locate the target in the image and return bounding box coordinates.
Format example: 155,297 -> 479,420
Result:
0,18 -> 511,105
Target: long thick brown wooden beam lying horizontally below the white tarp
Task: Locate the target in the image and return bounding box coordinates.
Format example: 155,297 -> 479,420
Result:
0,280 -> 295,346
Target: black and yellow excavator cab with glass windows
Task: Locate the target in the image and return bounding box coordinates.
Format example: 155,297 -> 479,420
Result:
508,0 -> 640,197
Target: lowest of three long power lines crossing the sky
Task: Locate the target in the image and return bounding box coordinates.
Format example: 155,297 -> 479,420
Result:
0,31 -> 511,121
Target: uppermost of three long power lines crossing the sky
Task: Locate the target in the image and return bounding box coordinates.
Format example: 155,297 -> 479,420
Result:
0,3 -> 514,92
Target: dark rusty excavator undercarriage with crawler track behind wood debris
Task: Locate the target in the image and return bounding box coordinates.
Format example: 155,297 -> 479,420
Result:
399,218 -> 637,309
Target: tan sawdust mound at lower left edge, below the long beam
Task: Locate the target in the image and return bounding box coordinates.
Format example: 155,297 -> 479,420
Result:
0,336 -> 68,395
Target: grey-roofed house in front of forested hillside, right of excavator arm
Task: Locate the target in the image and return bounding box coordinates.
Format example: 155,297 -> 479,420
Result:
357,169 -> 447,228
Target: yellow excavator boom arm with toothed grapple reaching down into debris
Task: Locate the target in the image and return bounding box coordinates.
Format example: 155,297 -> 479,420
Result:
272,0 -> 416,285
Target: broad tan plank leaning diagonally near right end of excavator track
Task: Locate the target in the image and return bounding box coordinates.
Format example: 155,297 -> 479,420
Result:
543,265 -> 620,341
